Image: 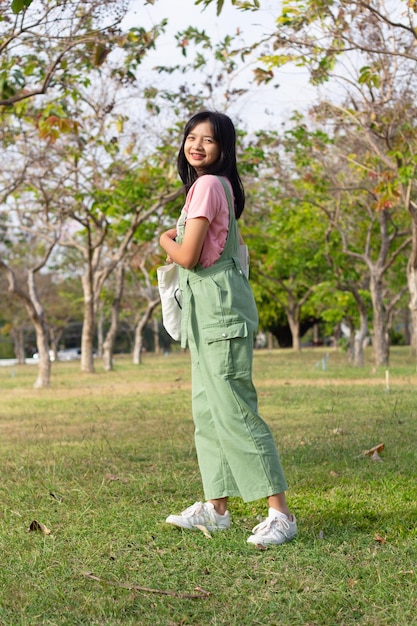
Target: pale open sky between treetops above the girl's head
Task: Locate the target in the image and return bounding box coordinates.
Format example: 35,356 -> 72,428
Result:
122,0 -> 315,130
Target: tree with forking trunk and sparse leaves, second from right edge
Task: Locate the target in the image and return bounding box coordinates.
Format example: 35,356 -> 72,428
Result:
282,116 -> 410,365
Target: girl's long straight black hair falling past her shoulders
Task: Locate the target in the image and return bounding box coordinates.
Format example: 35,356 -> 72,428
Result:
177,111 -> 245,219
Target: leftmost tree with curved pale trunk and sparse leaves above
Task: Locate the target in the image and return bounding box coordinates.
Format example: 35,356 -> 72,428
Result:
0,0 -> 171,385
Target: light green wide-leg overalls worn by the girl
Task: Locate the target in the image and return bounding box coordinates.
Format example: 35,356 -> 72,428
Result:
177,178 -> 287,502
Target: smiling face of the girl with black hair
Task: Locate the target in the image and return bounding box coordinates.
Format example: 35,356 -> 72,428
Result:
184,121 -> 220,176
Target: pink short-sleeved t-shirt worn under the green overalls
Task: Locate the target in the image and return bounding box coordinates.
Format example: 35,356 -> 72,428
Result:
180,174 -> 233,267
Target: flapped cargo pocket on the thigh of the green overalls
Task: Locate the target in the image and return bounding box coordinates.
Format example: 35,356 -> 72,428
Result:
201,320 -> 251,378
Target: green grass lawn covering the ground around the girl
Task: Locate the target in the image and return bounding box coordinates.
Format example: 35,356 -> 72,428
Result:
0,348 -> 417,626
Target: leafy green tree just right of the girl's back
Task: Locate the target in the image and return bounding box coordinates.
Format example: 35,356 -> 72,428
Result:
237,132 -> 328,350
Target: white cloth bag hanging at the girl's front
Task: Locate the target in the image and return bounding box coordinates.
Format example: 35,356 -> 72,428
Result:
156,263 -> 181,341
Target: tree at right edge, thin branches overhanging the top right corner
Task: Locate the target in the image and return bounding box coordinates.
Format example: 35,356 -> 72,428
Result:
199,0 -> 417,349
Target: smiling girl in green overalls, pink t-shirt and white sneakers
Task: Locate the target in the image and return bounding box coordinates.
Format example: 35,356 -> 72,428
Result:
160,111 -> 297,545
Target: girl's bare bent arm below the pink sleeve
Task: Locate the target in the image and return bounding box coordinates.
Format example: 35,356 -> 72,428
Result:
159,217 -> 209,270
